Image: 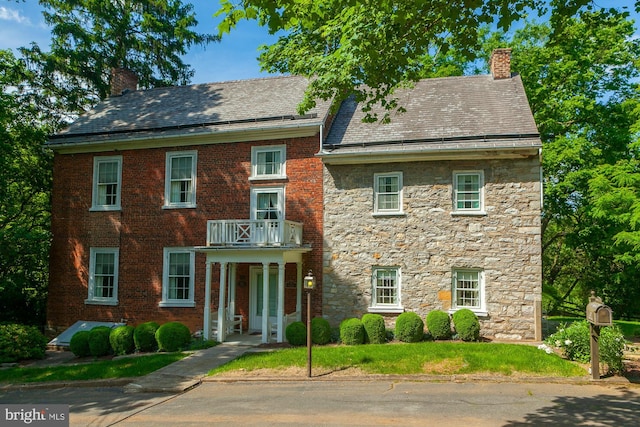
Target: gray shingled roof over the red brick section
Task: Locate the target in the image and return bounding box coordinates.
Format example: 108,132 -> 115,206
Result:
49,76 -> 330,144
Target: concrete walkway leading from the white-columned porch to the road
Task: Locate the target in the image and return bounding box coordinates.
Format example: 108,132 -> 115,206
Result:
124,334 -> 262,393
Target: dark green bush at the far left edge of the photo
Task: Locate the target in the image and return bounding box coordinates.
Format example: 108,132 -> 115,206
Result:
0,323 -> 47,363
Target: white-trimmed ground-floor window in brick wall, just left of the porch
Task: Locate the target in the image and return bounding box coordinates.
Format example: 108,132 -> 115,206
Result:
160,248 -> 195,307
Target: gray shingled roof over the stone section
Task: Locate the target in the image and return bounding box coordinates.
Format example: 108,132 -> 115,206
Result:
324,75 -> 540,153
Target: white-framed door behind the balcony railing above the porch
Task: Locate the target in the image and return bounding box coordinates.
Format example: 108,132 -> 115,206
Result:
251,187 -> 284,243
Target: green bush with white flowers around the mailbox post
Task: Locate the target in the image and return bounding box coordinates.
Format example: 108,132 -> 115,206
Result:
545,320 -> 625,373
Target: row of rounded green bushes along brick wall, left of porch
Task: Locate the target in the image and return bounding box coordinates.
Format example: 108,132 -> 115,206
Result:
69,322 -> 191,357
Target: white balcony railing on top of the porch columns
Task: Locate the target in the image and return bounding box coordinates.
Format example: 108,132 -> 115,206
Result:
207,219 -> 302,246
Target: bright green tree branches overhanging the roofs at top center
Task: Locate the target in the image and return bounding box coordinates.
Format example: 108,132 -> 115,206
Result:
217,0 -> 640,120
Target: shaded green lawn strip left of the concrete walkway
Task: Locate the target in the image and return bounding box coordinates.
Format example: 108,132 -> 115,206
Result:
0,353 -> 187,383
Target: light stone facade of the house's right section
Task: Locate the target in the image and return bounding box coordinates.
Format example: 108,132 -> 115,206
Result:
323,156 -> 542,340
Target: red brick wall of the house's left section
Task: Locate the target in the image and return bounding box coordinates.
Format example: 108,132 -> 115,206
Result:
47,136 -> 323,332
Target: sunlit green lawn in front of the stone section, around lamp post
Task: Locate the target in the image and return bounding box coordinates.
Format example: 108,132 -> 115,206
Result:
209,342 -> 586,377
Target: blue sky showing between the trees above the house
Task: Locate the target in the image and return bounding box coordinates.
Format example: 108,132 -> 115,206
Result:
0,0 -> 638,83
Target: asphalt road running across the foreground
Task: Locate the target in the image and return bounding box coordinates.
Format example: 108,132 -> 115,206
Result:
0,379 -> 640,427
